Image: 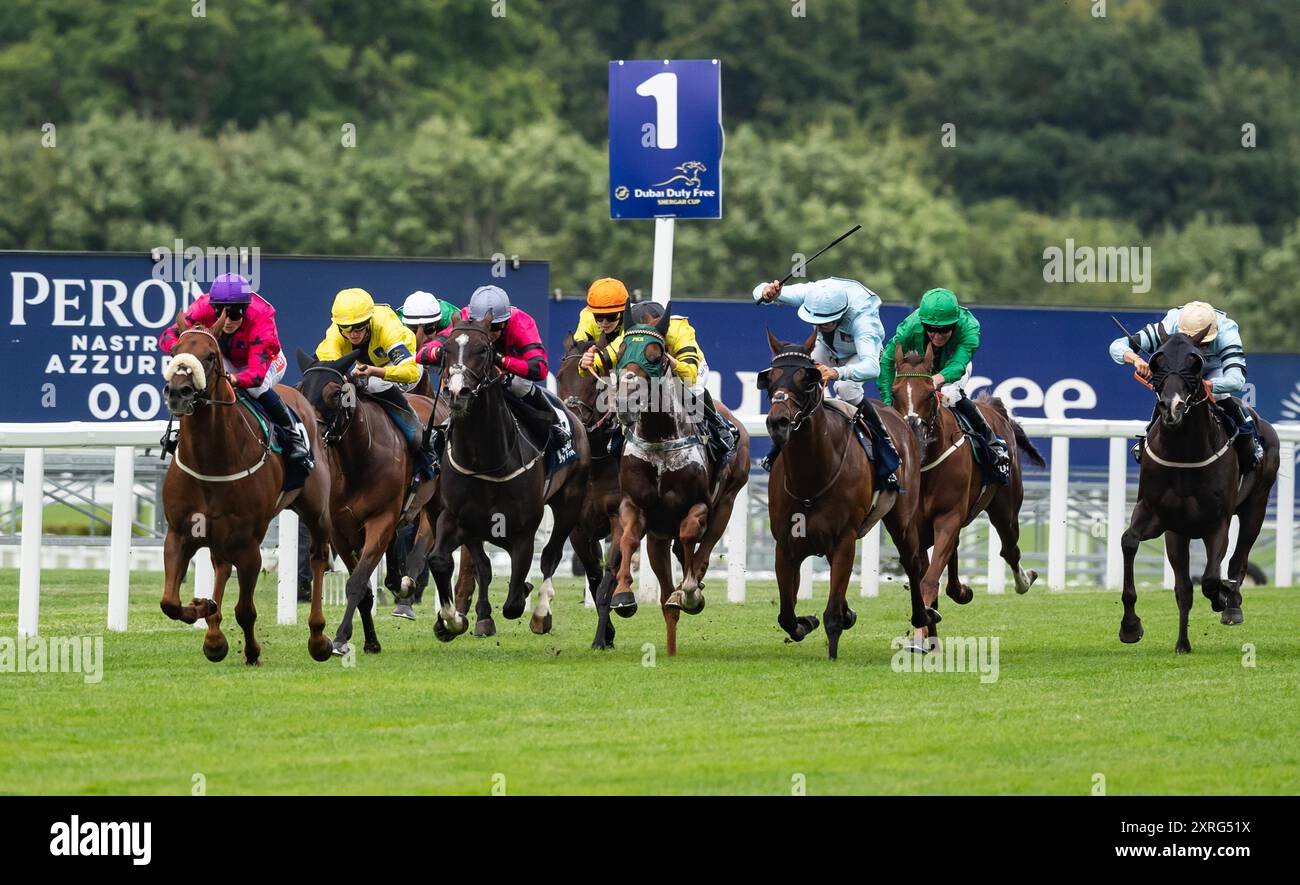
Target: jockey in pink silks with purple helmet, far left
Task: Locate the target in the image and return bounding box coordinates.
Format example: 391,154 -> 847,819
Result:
159,273 -> 312,469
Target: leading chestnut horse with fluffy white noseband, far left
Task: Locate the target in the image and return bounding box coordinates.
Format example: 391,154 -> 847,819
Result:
160,316 -> 330,664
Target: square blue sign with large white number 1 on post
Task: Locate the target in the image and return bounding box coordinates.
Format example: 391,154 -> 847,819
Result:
610,58 -> 723,218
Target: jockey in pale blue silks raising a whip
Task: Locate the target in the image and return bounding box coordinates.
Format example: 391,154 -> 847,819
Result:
754,277 -> 898,489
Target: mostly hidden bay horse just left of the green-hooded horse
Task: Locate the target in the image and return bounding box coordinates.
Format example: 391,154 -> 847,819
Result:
555,334 -> 623,648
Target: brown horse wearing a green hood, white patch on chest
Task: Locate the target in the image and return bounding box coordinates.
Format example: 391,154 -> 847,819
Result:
610,304 -> 749,655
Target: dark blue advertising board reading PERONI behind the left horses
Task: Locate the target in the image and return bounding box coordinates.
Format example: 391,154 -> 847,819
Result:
0,252 -> 550,422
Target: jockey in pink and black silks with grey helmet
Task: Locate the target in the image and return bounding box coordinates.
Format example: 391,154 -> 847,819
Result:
416,286 -> 569,450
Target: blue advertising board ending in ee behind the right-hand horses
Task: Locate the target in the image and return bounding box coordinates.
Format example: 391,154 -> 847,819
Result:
546,300 -> 1300,467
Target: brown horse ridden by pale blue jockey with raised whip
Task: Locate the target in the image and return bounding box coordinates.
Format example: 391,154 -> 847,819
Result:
758,330 -> 930,660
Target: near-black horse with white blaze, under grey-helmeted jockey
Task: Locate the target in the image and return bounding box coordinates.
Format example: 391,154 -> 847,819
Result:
429,312 -> 590,642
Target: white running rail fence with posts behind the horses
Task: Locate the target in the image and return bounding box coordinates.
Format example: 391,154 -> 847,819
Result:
0,415 -> 1300,635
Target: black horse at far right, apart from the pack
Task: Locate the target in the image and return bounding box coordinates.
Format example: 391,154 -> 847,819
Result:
1119,327 -> 1281,654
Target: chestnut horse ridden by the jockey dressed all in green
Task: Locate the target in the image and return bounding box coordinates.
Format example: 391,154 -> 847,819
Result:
892,344 -> 1047,654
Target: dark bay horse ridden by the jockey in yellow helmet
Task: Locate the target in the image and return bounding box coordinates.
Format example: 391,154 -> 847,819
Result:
298,351 -> 434,654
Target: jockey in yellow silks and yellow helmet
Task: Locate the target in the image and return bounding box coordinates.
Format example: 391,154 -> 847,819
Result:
316,289 -> 433,480
